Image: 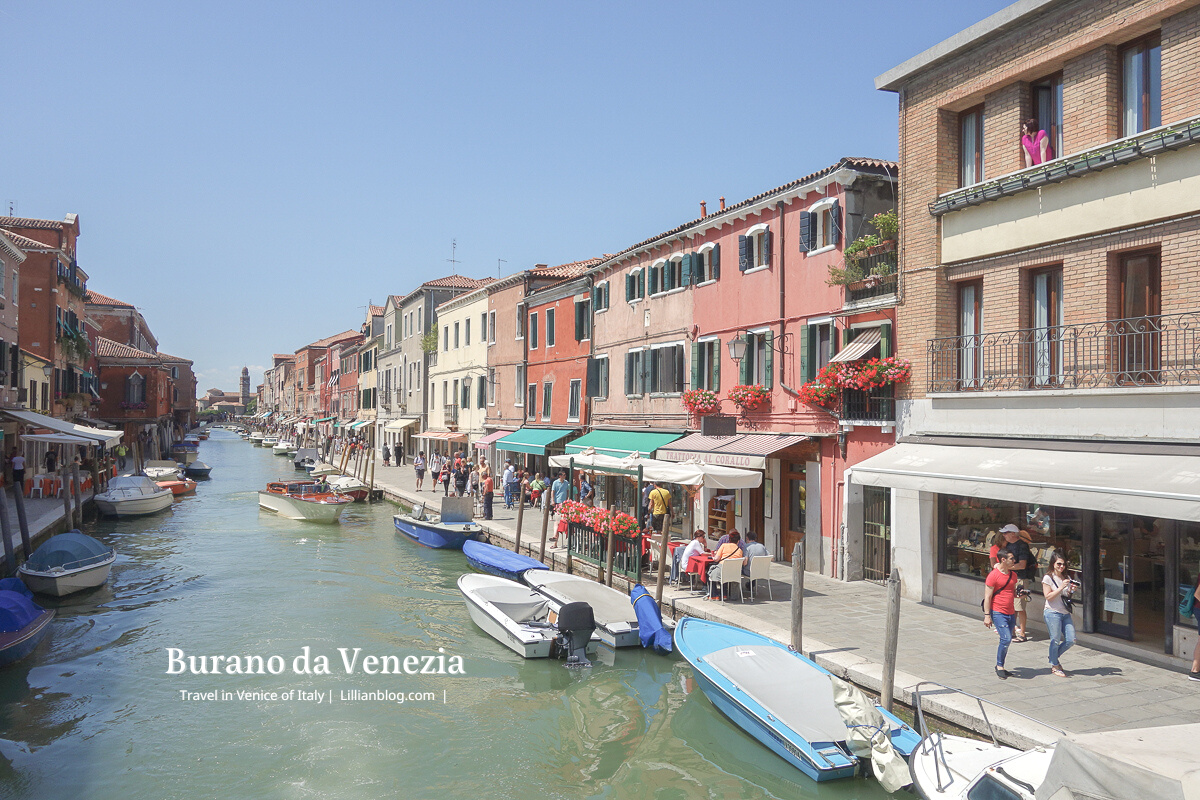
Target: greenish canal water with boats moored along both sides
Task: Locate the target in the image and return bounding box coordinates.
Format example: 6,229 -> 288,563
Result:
0,431 -> 902,800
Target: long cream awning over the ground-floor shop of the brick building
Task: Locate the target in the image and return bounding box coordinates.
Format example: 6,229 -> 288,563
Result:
848,443 -> 1200,522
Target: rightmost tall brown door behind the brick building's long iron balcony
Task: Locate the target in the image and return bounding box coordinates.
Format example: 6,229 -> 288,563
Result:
1115,253 -> 1162,385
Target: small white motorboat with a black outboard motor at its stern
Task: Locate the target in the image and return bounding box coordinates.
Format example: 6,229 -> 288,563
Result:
458,572 -> 594,666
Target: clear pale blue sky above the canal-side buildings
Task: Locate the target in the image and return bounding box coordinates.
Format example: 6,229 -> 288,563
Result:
0,0 -> 1007,392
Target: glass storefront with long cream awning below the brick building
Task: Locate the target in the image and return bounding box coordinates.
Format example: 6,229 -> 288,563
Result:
846,443 -> 1200,657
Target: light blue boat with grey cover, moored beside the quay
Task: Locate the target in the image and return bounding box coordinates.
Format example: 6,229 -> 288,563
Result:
674,616 -> 920,792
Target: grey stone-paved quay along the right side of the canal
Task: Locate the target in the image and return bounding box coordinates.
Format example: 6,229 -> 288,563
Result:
360,465 -> 1200,747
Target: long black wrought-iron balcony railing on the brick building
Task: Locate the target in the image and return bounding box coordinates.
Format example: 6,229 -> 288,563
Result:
928,312 -> 1200,392
